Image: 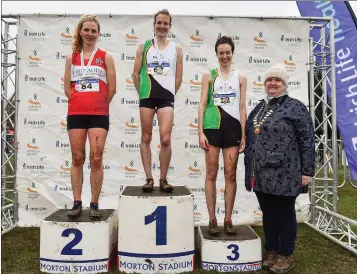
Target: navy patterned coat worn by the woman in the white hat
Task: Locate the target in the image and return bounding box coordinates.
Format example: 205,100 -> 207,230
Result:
244,95 -> 315,196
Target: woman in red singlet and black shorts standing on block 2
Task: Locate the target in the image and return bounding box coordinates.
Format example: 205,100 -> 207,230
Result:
64,15 -> 116,218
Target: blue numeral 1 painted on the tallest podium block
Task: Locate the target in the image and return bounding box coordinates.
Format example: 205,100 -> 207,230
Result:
145,206 -> 167,245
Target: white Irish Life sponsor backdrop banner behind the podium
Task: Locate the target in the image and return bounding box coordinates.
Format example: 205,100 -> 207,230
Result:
17,15 -> 309,226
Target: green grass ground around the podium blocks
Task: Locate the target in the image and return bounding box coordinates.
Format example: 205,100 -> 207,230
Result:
1,166 -> 357,274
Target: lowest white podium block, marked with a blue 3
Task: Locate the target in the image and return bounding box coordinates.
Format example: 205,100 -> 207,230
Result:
198,226 -> 262,272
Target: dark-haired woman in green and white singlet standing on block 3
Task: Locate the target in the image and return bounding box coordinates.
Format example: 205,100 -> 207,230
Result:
198,36 -> 247,236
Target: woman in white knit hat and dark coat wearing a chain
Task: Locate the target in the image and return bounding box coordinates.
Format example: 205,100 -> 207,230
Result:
244,66 -> 315,273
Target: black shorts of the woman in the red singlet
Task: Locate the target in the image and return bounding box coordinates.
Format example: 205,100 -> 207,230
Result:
67,115 -> 109,131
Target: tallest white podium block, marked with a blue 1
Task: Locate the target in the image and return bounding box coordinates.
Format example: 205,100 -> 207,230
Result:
118,186 -> 194,273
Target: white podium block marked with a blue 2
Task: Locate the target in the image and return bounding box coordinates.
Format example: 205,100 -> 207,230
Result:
40,209 -> 118,274
